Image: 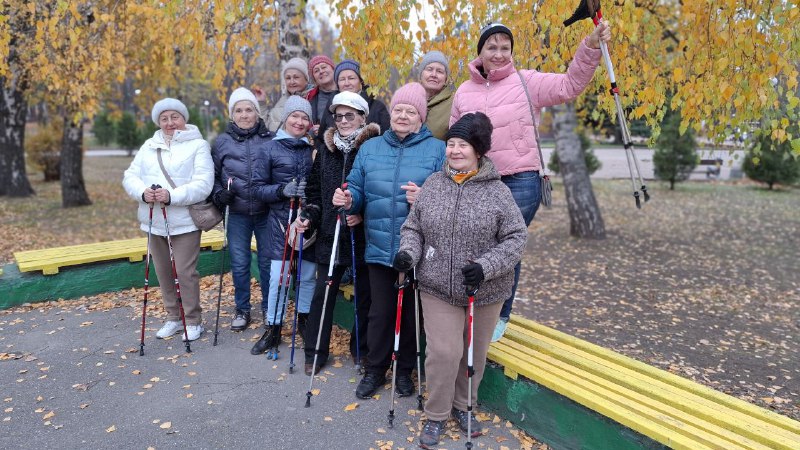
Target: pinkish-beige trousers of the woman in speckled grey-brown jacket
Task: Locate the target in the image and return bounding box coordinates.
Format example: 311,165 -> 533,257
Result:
421,292 -> 503,421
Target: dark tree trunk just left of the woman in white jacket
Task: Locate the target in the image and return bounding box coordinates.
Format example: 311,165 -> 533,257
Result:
61,118 -> 92,208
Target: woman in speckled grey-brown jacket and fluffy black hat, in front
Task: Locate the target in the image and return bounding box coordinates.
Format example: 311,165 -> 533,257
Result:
393,112 -> 527,448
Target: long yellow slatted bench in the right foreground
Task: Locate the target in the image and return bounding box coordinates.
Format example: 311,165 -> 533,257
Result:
489,316 -> 800,450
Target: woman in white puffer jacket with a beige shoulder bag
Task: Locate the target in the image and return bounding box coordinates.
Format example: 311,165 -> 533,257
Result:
122,98 -> 214,341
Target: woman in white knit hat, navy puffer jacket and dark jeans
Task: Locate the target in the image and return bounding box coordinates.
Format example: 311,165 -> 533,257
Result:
211,88 -> 272,331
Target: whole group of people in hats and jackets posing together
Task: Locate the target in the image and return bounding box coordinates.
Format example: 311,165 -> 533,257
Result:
124,23 -> 610,448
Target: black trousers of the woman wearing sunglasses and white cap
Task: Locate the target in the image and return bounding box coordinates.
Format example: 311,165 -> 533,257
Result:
304,264 -> 370,365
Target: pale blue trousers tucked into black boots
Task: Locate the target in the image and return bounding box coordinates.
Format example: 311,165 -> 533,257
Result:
264,259 -> 317,325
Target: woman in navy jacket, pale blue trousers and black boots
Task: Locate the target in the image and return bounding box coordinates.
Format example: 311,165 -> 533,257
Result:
250,95 -> 317,355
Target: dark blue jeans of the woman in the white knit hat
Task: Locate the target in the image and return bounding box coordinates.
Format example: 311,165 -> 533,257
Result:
228,213 -> 270,312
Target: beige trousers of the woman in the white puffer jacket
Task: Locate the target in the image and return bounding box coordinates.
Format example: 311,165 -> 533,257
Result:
150,231 -> 202,325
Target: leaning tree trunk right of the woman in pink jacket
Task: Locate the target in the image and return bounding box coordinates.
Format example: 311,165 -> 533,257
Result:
553,102 -> 606,239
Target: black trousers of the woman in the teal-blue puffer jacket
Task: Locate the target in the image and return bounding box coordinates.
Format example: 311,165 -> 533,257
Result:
367,264 -> 417,375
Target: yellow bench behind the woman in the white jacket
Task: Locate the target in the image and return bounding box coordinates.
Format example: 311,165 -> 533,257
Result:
14,230 -> 230,275
